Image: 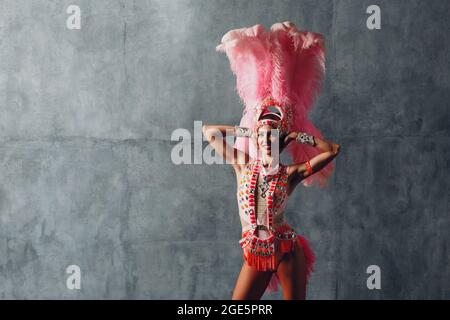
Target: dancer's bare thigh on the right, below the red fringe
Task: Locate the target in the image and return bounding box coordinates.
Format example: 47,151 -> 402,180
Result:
277,241 -> 306,300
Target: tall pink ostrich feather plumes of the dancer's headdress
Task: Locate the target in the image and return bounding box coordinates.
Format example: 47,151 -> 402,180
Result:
216,21 -> 333,187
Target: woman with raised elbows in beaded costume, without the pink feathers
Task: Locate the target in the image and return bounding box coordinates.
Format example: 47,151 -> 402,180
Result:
203,98 -> 340,300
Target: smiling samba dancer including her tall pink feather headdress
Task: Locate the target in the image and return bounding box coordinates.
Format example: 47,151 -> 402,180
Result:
203,21 -> 340,299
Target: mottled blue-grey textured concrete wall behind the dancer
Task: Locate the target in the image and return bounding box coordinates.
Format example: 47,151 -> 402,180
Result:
0,0 -> 450,299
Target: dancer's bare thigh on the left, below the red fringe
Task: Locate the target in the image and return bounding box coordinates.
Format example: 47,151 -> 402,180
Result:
231,261 -> 272,300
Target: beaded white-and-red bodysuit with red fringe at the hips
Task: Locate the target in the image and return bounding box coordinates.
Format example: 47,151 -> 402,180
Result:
237,160 -> 314,292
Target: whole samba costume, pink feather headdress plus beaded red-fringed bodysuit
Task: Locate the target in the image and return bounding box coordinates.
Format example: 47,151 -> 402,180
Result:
216,21 -> 333,292
